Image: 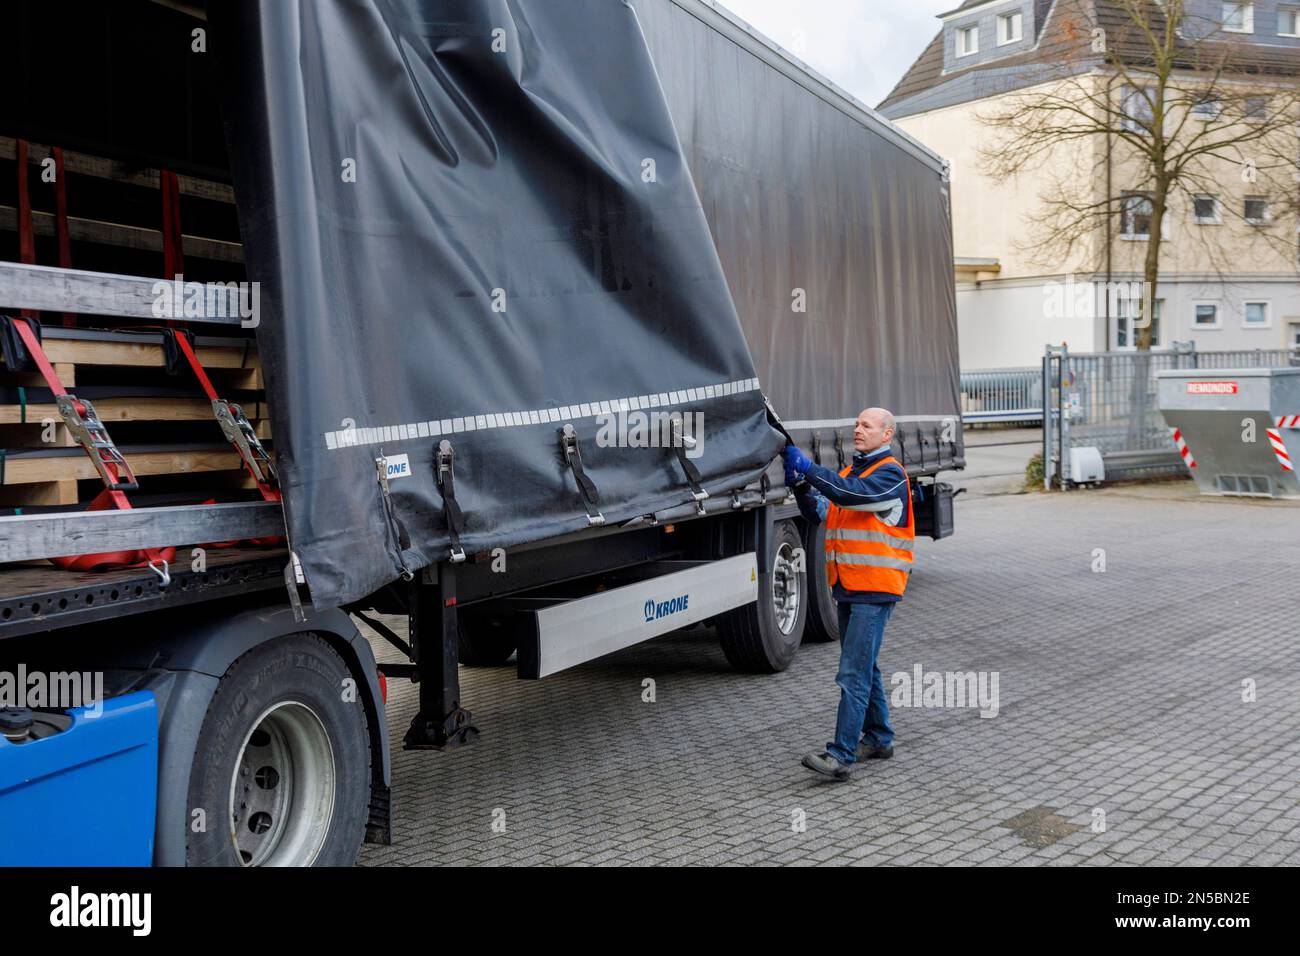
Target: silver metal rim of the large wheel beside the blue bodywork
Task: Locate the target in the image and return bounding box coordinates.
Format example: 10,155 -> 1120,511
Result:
230,701 -> 334,866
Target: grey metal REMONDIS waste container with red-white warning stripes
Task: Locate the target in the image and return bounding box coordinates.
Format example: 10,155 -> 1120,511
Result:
1158,368 -> 1300,498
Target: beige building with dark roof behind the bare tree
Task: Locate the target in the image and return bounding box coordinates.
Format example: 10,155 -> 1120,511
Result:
879,0 -> 1300,369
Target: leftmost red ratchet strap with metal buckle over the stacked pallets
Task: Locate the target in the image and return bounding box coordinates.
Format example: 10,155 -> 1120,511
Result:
8,317 -> 176,574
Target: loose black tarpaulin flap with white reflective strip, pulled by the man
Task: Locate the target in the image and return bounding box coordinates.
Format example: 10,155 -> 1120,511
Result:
211,0 -> 783,607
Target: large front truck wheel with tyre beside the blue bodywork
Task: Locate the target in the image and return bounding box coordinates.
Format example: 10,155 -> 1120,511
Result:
186,633 -> 371,866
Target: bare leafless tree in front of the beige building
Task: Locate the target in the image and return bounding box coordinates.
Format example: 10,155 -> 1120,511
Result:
980,0 -> 1300,350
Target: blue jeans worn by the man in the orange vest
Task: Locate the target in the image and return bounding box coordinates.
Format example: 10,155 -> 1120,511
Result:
826,602 -> 893,763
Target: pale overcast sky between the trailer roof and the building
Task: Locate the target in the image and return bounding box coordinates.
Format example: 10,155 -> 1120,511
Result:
719,0 -> 961,107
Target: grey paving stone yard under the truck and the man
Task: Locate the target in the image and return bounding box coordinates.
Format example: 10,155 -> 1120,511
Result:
361,485 -> 1300,866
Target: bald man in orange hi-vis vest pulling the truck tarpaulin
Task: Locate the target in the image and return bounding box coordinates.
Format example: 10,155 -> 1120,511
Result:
785,408 -> 915,782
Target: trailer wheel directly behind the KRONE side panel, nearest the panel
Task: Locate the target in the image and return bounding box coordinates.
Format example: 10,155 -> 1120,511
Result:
718,522 -> 807,674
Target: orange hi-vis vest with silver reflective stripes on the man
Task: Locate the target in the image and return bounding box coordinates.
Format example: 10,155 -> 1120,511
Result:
826,455 -> 917,597
